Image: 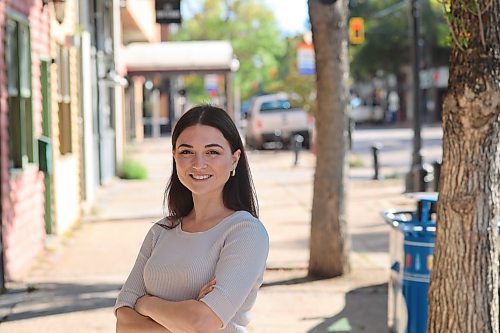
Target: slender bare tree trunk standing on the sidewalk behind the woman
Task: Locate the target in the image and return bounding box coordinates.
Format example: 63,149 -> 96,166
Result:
309,0 -> 350,277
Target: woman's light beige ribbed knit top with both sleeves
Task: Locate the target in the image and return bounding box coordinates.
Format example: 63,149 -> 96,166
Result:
115,211 -> 269,333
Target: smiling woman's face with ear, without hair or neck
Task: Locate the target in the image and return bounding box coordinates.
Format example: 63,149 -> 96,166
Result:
174,125 -> 241,195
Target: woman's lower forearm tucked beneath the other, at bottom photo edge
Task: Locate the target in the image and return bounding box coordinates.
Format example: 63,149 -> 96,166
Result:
116,307 -> 172,333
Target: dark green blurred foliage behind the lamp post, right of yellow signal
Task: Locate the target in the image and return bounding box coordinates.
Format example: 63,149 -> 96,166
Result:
350,0 -> 449,80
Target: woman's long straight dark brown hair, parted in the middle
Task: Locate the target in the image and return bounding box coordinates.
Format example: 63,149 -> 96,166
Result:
163,104 -> 258,227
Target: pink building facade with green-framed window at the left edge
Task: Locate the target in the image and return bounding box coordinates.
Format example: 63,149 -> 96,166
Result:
0,0 -> 51,279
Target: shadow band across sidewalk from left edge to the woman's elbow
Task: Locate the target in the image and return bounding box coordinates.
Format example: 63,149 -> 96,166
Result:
0,283 -> 121,323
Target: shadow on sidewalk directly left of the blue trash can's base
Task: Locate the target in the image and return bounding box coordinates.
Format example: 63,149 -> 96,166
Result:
308,283 -> 388,333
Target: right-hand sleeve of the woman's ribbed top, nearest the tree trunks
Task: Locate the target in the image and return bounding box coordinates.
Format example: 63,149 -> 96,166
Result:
201,220 -> 269,326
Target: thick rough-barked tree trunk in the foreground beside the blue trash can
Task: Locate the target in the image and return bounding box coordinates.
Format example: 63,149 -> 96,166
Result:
427,0 -> 500,333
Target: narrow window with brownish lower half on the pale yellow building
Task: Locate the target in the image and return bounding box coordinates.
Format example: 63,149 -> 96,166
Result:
57,46 -> 73,155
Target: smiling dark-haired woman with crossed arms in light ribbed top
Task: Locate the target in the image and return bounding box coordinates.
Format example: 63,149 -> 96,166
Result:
115,105 -> 269,333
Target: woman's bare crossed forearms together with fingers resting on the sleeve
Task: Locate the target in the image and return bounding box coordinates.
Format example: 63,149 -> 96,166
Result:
116,280 -> 222,333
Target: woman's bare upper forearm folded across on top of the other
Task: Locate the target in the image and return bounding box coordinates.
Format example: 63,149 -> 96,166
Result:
136,296 -> 222,332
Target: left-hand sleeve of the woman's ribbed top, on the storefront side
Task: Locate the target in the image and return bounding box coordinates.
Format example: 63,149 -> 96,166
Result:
114,225 -> 158,314
